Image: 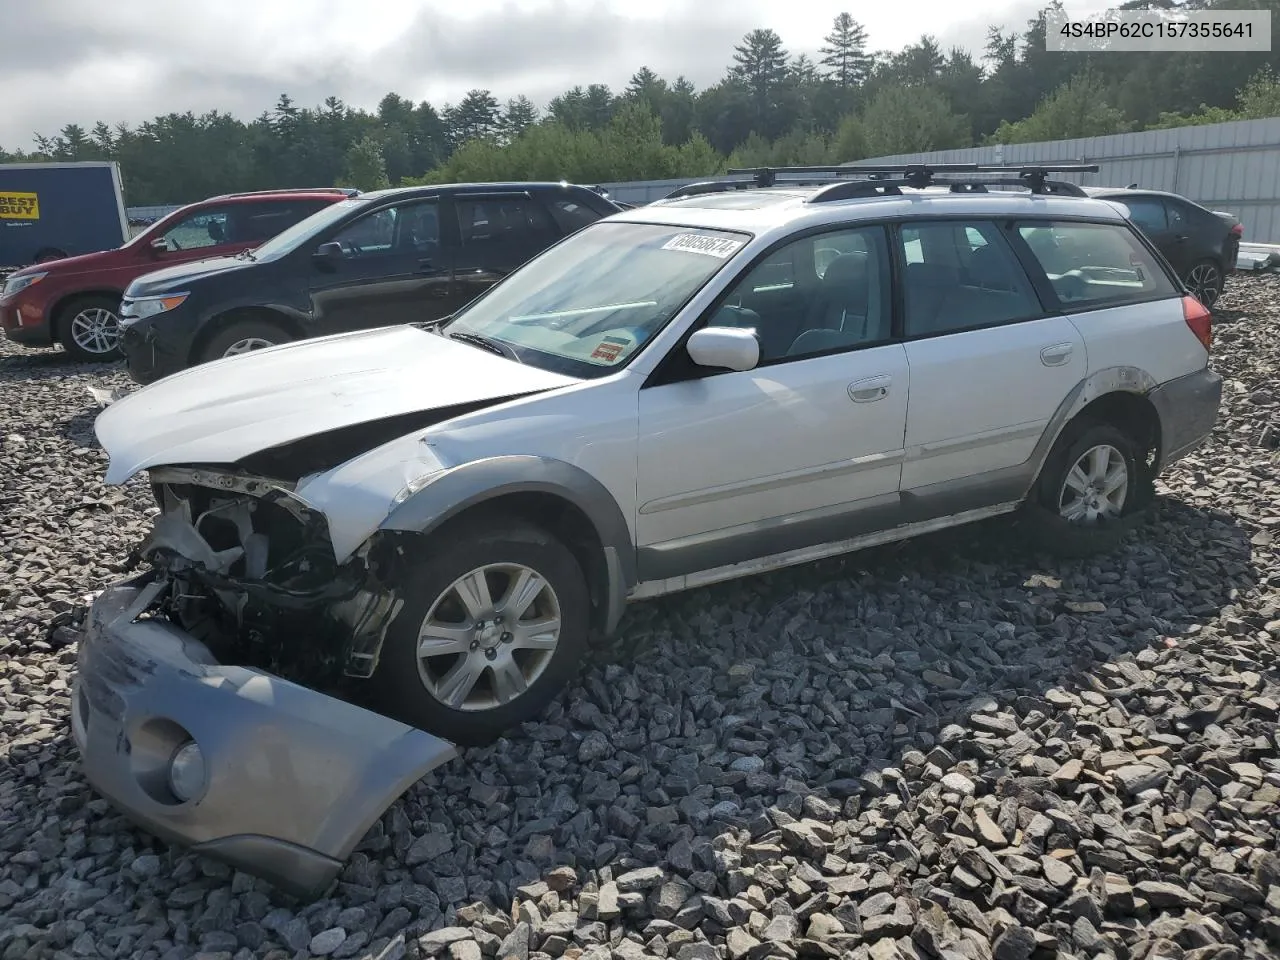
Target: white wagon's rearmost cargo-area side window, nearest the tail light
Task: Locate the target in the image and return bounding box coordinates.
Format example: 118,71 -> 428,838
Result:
1018,223 -> 1178,306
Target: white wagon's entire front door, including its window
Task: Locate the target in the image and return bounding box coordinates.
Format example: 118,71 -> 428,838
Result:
636,227 -> 909,580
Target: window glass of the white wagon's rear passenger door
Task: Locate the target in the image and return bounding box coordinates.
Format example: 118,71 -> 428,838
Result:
900,220 -> 1043,337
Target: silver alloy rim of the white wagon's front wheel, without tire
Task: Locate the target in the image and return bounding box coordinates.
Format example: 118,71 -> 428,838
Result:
417,563 -> 561,710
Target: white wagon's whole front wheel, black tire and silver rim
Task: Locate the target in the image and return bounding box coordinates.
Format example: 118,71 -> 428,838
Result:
370,517 -> 591,746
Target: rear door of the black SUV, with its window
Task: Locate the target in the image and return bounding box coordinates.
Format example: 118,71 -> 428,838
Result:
448,191 -> 563,312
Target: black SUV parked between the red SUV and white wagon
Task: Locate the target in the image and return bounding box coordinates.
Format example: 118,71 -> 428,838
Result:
120,183 -> 618,384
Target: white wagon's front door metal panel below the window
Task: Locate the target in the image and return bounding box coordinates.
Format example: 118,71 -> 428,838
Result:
636,344 -> 909,547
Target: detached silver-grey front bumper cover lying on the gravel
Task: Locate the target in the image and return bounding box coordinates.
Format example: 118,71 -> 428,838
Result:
72,576 -> 457,897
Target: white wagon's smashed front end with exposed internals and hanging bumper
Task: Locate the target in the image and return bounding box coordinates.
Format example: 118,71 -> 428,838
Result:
72,467 -> 457,897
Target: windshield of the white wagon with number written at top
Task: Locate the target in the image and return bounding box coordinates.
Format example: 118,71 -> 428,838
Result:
443,221 -> 750,378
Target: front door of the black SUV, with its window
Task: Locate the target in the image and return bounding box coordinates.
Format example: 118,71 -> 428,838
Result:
310,198 -> 452,333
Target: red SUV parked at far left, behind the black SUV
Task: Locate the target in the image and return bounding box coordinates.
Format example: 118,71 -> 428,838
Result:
0,187 -> 360,360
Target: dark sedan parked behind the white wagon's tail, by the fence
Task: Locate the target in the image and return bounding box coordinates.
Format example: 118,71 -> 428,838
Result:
1084,187 -> 1244,307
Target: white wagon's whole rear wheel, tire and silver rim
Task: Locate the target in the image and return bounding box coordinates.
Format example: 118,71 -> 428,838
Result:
1023,421 -> 1153,557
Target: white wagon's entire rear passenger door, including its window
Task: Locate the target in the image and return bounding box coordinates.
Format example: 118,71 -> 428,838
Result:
897,219 -> 1088,504
